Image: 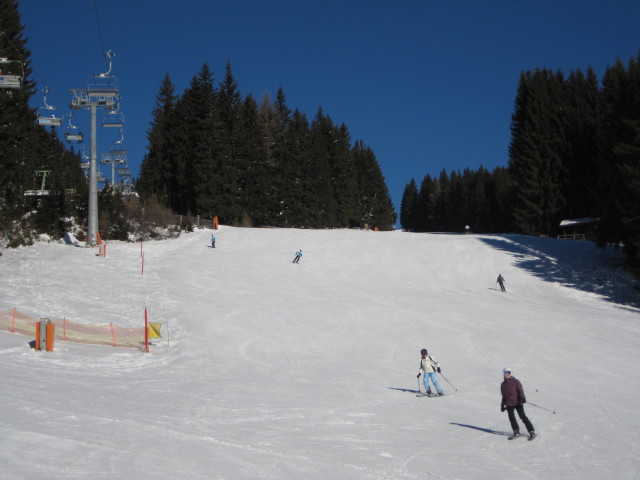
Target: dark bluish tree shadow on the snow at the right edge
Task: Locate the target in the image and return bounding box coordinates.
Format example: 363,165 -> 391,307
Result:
480,234 -> 640,311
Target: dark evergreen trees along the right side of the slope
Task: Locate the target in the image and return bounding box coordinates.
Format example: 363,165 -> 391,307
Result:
400,54 -> 640,269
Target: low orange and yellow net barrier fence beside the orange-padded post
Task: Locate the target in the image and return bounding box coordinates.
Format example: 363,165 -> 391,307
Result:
0,308 -> 148,351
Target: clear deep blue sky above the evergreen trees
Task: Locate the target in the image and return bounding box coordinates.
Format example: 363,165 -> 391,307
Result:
19,0 -> 640,211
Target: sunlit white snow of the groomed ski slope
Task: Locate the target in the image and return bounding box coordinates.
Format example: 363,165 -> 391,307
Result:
0,227 -> 640,480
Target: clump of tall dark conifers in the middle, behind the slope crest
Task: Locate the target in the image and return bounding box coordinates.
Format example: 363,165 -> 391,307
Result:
136,62 -> 396,230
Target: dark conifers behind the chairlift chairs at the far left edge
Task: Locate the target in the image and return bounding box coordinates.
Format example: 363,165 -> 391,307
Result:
0,0 -> 86,240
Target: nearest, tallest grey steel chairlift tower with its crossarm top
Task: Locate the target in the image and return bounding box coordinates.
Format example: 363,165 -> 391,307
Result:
70,51 -> 119,246
